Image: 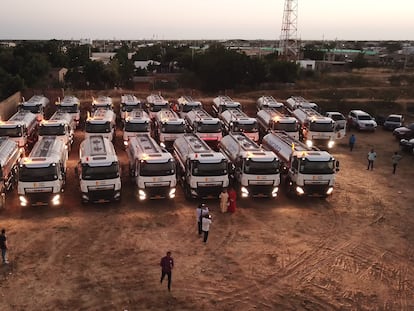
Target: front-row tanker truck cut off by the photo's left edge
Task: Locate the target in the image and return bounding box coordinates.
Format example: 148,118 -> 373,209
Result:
0,137 -> 21,208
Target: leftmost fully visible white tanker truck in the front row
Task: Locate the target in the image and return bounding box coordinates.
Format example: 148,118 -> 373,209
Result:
17,136 -> 68,206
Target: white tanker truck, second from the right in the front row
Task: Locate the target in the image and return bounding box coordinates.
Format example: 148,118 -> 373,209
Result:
219,133 -> 280,198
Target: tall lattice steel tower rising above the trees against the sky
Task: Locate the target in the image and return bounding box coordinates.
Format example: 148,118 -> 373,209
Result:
279,0 -> 299,60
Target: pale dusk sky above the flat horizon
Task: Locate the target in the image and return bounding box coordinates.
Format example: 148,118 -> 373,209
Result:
0,0 -> 414,40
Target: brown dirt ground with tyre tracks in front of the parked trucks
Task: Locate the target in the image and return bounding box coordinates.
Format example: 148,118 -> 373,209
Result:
0,106 -> 414,311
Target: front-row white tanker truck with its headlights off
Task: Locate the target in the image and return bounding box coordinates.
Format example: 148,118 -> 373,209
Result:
75,135 -> 121,203
